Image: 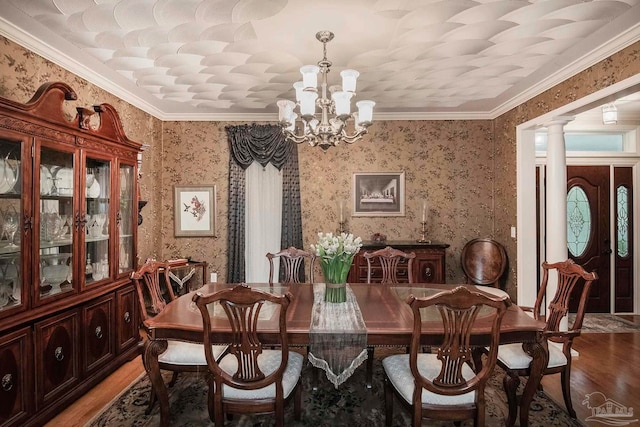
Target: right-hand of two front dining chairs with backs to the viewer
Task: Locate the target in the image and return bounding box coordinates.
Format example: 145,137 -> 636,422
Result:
382,286 -> 511,426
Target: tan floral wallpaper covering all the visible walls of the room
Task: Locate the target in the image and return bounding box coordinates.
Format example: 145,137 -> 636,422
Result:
0,37 -> 640,297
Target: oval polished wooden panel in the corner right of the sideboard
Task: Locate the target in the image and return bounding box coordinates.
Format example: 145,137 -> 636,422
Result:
460,239 -> 507,288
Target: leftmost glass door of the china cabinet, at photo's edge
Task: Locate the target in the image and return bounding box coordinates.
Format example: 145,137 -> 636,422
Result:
0,139 -> 23,312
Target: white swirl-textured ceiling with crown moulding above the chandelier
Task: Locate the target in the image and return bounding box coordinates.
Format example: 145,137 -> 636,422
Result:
0,0 -> 640,120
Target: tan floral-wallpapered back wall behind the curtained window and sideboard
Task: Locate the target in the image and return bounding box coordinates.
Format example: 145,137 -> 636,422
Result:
161,120 -> 494,282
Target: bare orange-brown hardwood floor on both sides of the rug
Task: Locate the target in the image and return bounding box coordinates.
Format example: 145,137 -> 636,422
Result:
46,328 -> 640,427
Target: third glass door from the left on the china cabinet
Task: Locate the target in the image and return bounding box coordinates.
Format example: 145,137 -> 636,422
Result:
84,157 -> 111,285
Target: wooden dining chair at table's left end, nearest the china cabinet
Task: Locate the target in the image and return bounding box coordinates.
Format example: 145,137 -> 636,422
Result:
131,259 -> 227,414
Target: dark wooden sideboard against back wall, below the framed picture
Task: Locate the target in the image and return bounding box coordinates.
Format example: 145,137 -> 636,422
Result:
348,241 -> 449,283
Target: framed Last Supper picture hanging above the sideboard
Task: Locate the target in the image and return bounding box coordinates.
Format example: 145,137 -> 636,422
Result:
353,172 -> 404,216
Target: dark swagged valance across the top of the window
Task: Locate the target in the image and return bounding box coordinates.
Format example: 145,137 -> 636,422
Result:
225,123 -> 295,170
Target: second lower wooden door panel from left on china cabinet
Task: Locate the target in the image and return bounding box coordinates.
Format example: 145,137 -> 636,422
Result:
35,310 -> 80,410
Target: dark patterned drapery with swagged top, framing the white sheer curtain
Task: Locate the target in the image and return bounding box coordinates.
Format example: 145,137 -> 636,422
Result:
225,123 -> 304,283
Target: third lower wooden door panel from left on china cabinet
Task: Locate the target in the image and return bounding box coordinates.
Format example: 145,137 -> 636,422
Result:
82,294 -> 115,373
